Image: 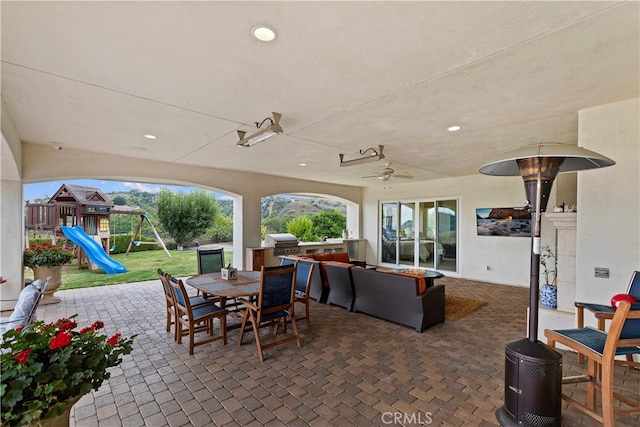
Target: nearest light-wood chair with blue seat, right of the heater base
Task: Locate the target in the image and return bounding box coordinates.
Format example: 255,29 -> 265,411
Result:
544,301 -> 640,427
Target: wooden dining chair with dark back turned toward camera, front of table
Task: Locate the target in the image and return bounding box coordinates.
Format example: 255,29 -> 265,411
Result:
238,265 -> 302,361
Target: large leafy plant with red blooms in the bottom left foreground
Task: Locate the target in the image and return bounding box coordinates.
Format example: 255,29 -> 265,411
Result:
0,315 -> 135,426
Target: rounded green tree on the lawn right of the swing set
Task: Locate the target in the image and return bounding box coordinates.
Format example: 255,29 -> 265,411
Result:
157,188 -> 219,246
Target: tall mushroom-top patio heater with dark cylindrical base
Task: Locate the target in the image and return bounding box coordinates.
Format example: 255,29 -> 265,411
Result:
480,142 -> 615,427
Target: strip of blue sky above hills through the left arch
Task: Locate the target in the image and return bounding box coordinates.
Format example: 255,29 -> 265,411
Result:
24,179 -> 227,201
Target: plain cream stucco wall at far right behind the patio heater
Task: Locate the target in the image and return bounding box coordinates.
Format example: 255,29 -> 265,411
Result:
576,98 -> 640,321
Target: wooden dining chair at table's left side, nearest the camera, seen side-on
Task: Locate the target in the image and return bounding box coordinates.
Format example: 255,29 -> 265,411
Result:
166,275 -> 227,355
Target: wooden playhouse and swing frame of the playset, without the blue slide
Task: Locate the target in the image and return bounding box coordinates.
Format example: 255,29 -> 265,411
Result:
25,184 -> 171,268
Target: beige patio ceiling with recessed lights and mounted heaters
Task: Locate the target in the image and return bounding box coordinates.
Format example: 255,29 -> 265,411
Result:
1,1 -> 640,186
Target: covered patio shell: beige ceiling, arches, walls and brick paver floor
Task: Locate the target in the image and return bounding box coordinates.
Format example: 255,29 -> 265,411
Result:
0,1 -> 640,426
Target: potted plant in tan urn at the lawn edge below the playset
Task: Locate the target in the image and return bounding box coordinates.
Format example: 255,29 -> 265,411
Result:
23,243 -> 73,304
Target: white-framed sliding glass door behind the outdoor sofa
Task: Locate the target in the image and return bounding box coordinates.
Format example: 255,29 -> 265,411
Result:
379,200 -> 458,271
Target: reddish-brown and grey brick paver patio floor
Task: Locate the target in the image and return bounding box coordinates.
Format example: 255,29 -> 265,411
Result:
38,278 -> 640,427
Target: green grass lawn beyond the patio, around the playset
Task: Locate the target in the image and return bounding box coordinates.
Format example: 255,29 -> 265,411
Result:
25,250 -> 233,289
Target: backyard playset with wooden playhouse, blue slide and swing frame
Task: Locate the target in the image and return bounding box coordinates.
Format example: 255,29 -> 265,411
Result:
25,184 -> 171,274
